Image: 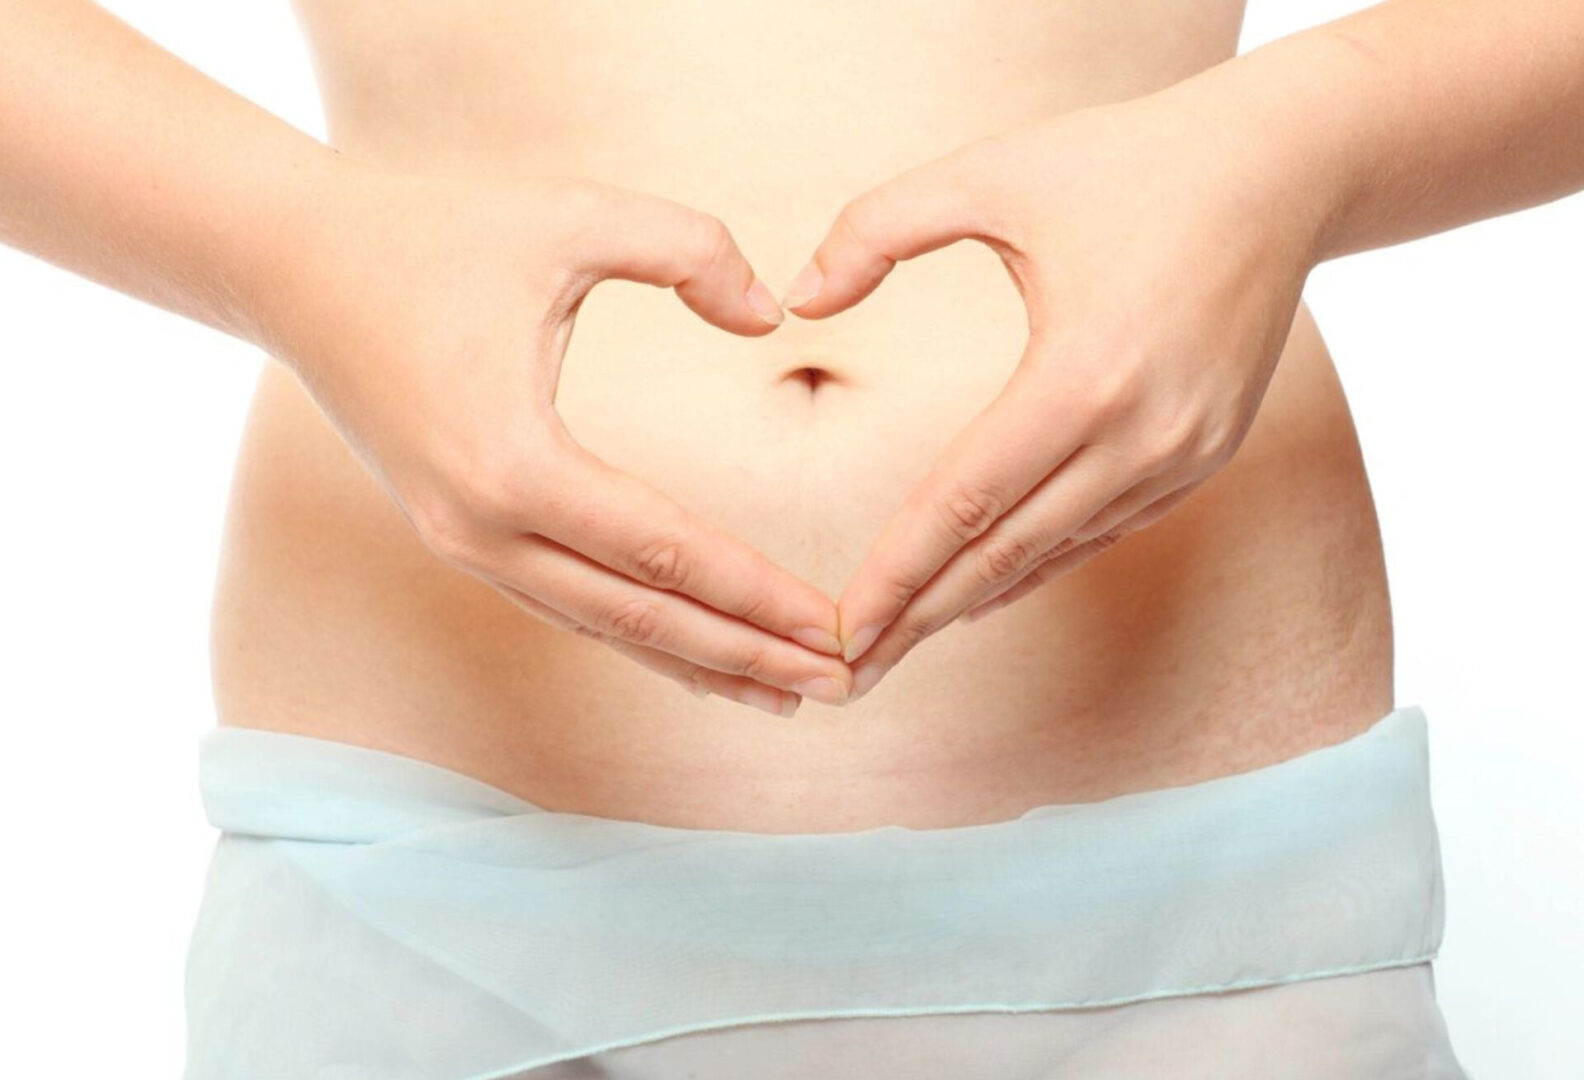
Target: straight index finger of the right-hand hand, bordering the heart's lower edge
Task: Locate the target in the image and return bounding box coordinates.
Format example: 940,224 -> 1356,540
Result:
836,354 -> 1083,662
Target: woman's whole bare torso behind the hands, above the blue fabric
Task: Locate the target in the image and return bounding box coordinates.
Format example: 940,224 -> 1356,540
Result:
214,0 -> 1394,831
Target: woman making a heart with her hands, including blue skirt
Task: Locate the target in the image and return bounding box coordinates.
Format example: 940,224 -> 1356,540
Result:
0,0 -> 1584,1077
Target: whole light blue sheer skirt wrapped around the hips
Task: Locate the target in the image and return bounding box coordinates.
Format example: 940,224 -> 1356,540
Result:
185,706 -> 1462,1080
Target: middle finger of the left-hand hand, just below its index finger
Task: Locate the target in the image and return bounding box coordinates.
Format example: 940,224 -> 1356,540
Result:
480,525 -> 851,705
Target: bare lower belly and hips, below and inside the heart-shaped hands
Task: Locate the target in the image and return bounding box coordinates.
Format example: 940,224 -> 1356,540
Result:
212,261 -> 1392,830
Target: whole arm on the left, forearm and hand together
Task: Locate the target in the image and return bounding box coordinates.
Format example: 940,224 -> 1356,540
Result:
0,0 -> 851,713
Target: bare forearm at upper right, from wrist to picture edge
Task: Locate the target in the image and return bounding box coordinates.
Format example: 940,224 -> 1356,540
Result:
1167,0 -> 1584,263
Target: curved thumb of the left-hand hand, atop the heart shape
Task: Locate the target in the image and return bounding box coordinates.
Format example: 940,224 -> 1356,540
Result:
572,184 -> 784,336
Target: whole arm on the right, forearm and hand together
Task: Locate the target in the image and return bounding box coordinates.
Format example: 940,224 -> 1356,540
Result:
782,0 -> 1584,700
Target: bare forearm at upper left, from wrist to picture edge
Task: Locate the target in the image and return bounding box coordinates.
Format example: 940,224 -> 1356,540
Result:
0,0 -> 337,344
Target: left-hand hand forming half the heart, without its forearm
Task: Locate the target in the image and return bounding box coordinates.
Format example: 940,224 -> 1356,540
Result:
261,163 -> 852,716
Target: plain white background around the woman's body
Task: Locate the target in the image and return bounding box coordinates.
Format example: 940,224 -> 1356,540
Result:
0,0 -> 1584,1080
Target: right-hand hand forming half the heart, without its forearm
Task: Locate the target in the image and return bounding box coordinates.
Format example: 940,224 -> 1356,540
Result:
784,95 -> 1318,698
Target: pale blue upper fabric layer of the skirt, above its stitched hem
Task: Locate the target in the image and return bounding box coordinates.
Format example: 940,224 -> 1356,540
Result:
188,705 -> 1443,1080
